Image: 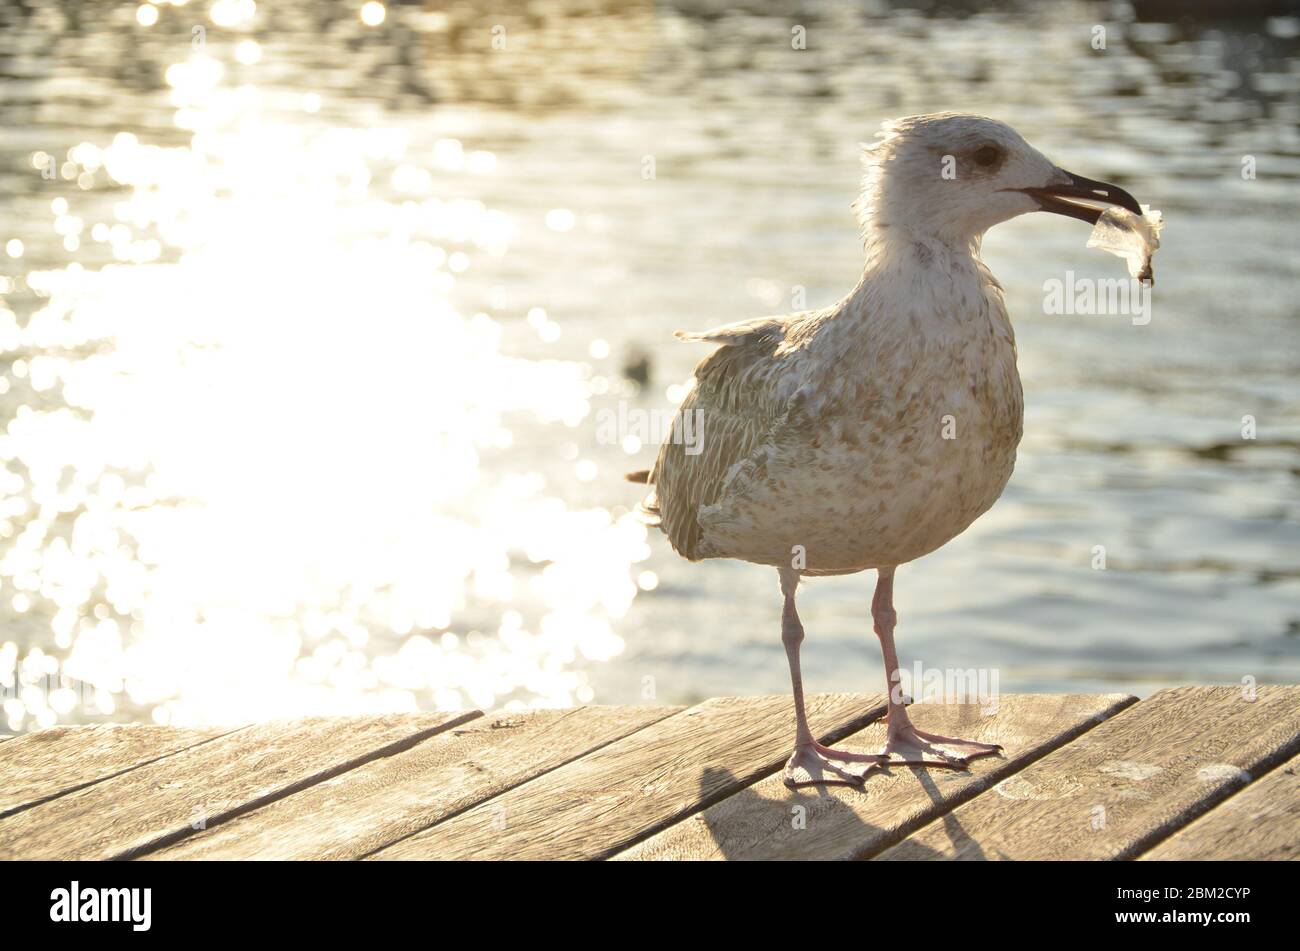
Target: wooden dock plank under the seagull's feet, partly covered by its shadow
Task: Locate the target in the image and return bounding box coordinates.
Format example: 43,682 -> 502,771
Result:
614,694 -> 1136,860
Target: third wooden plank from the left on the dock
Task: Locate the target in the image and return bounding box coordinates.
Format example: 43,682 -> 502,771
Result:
147,707 -> 681,859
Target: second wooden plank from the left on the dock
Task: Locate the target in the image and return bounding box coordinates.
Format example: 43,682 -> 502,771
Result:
0,712 -> 478,859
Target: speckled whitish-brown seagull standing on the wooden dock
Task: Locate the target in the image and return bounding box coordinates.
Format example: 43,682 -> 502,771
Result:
628,113 -> 1143,786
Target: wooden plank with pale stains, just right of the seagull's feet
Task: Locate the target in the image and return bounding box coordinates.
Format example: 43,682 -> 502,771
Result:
879,686 -> 1300,859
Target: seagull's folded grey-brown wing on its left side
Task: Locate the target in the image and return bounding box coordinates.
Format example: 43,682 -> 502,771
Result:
640,317 -> 792,561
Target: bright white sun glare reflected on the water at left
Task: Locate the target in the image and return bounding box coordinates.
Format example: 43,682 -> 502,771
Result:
0,37 -> 650,729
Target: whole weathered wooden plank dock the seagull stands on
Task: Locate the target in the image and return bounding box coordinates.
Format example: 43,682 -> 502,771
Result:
0,686 -> 1300,860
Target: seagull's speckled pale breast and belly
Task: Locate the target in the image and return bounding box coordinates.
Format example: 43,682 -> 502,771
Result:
699,262 -> 1023,574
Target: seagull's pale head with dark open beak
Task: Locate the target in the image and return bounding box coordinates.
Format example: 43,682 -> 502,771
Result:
855,113 -> 1141,246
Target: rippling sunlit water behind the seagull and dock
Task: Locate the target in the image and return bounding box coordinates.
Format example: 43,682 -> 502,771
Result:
0,0 -> 1300,730
